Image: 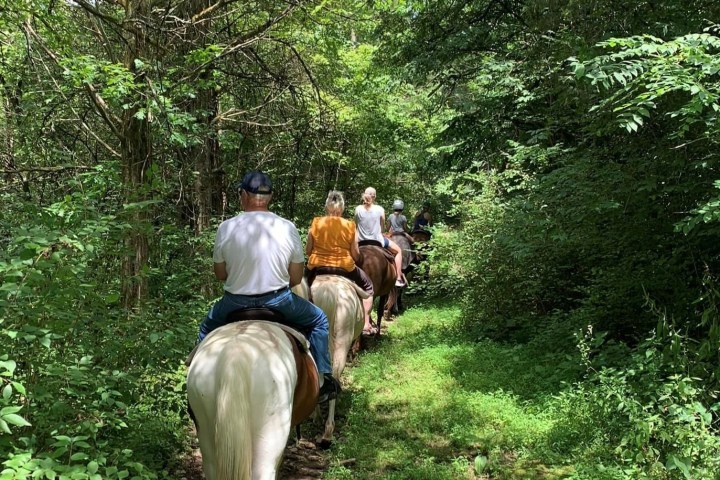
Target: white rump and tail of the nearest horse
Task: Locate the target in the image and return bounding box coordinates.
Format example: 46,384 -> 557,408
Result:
187,322 -> 298,480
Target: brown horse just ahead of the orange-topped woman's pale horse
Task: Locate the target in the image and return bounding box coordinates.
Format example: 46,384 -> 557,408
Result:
358,244 -> 397,335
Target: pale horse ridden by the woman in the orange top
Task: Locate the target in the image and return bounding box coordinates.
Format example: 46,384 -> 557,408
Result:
311,275 -> 368,445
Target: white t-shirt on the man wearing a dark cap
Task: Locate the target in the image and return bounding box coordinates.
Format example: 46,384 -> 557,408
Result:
213,212 -> 305,295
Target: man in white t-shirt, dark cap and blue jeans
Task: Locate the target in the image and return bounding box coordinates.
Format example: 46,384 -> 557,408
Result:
198,172 -> 340,402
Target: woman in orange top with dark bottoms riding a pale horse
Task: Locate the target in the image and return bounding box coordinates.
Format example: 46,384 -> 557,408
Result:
305,190 -> 377,335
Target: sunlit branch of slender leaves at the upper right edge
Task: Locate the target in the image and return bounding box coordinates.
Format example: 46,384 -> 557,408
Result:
569,27 -> 720,138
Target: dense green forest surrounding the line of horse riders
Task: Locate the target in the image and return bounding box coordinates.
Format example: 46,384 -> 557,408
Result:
0,0 -> 720,480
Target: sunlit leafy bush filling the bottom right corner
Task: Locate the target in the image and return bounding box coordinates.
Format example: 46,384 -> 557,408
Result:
558,337 -> 720,479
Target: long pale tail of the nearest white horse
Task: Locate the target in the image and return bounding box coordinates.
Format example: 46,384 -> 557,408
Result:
215,348 -> 253,480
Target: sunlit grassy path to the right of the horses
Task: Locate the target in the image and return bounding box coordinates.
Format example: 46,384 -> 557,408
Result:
325,304 -> 574,480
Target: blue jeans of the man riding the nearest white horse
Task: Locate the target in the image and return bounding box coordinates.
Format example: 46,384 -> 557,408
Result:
198,289 -> 332,374
